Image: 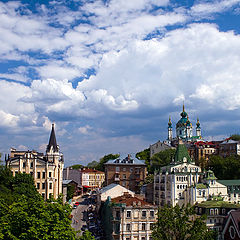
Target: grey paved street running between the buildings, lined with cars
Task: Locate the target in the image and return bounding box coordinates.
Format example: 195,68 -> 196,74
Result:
71,197 -> 88,236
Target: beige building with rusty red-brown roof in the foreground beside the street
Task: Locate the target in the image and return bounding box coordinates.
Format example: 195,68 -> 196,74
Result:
101,193 -> 158,240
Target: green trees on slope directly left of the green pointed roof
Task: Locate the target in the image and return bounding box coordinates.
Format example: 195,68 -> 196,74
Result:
150,149 -> 176,173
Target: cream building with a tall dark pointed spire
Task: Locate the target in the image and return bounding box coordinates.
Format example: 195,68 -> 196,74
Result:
6,124 -> 64,199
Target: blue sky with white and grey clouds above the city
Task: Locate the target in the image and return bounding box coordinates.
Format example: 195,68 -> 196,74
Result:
0,0 -> 240,166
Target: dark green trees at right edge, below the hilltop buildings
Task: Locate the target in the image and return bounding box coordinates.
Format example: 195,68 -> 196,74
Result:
207,155 -> 240,179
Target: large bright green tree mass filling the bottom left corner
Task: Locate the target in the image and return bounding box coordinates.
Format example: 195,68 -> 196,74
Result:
0,167 -> 76,240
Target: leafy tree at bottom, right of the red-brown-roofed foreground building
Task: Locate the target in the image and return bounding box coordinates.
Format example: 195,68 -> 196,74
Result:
152,205 -> 216,240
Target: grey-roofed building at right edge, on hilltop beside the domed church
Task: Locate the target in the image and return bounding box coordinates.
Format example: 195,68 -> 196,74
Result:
219,138 -> 240,157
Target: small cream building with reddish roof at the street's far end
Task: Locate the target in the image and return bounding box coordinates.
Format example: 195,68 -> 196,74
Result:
80,168 -> 105,191
